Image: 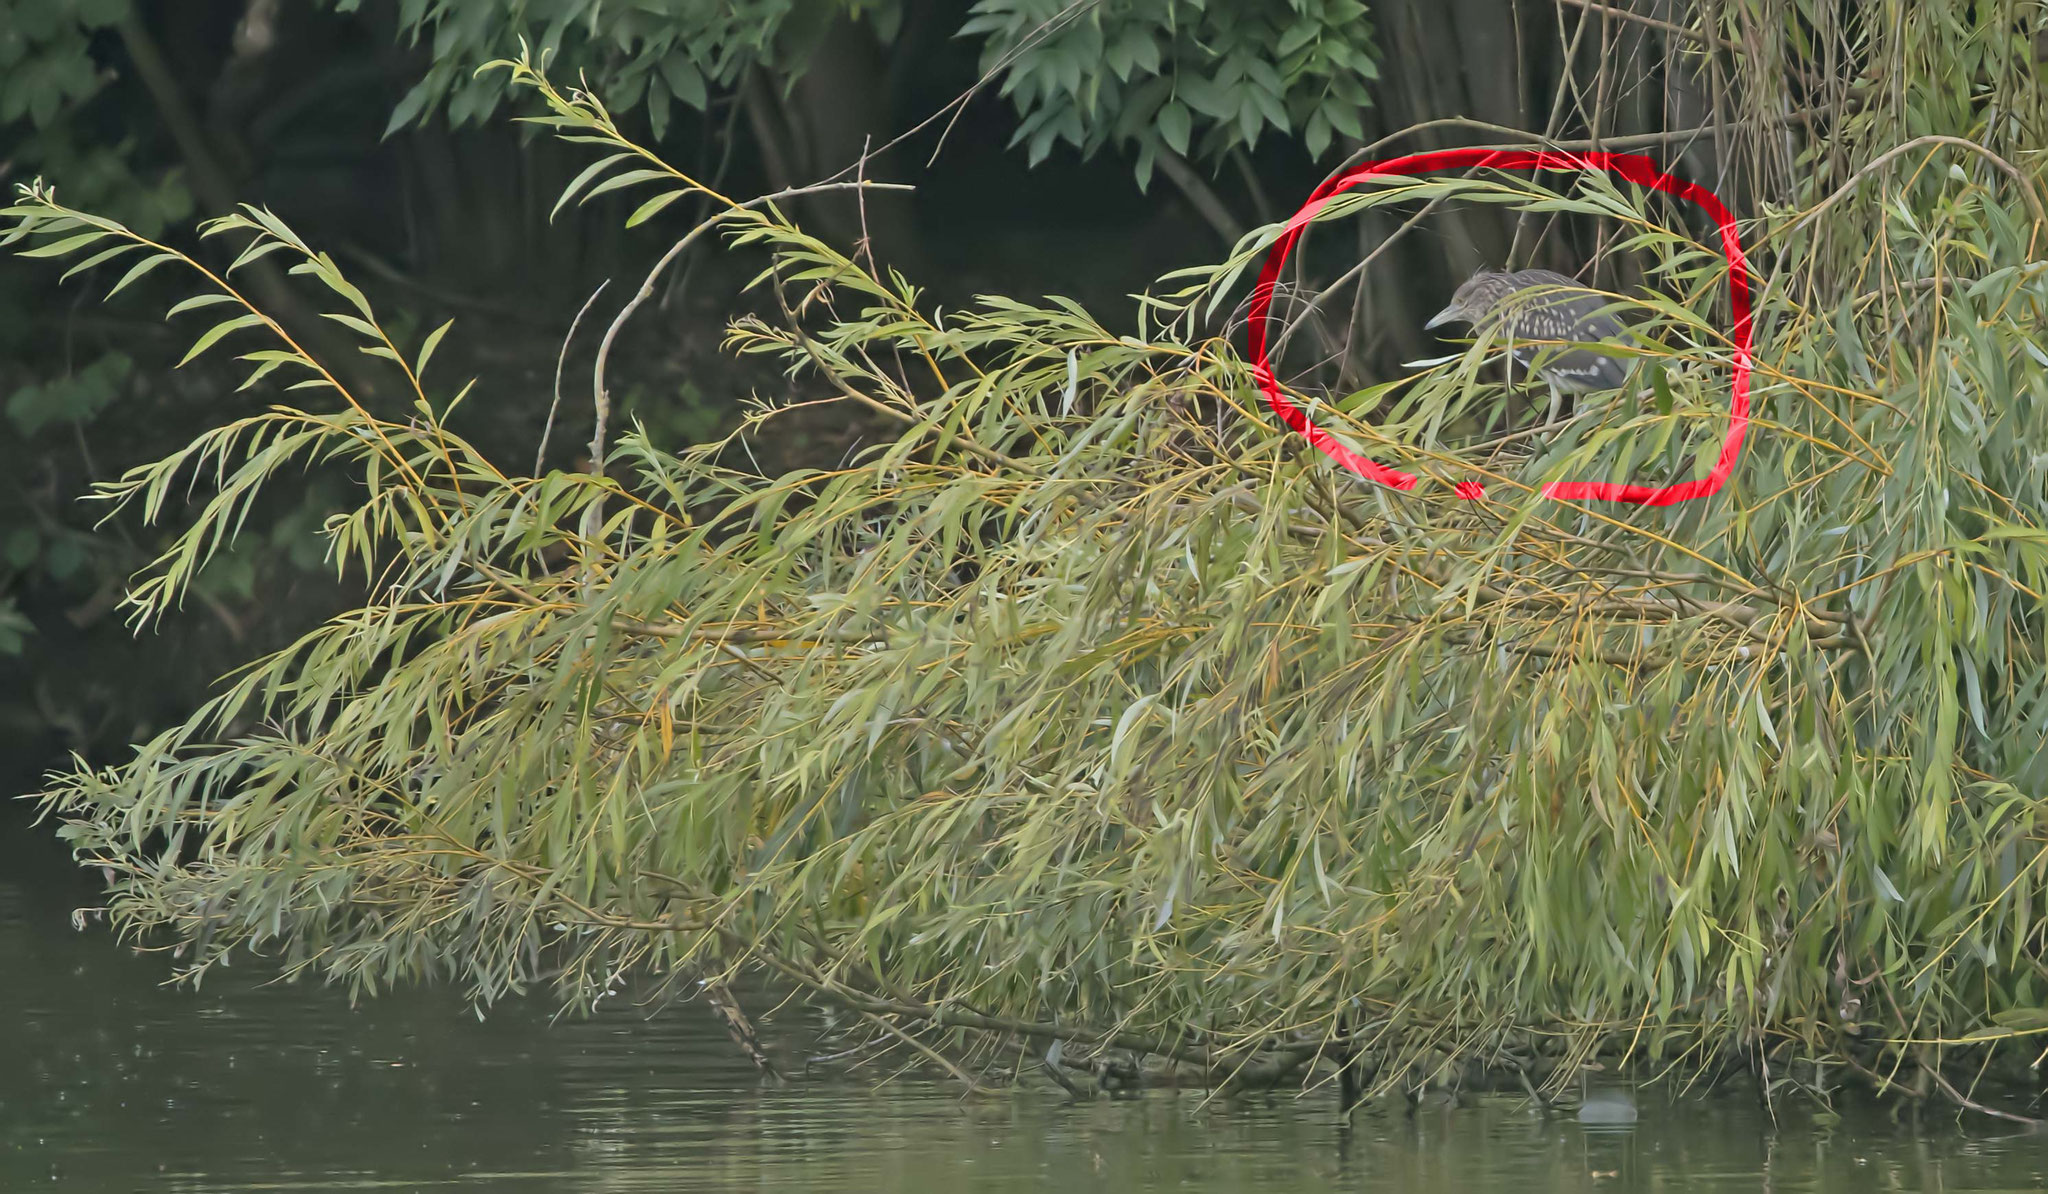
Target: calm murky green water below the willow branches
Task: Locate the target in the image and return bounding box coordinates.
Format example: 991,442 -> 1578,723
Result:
0,817 -> 2048,1194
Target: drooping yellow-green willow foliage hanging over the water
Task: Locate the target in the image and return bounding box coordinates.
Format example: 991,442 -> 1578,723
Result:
6,4 -> 2048,1114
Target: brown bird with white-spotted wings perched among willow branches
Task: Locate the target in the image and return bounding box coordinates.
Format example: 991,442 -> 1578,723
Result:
1423,270 -> 1628,393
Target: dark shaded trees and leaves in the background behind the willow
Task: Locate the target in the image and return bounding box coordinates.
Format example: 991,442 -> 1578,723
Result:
0,0 -> 1729,764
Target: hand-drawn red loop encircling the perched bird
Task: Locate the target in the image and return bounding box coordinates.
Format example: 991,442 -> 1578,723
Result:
1245,150 -> 1749,506
